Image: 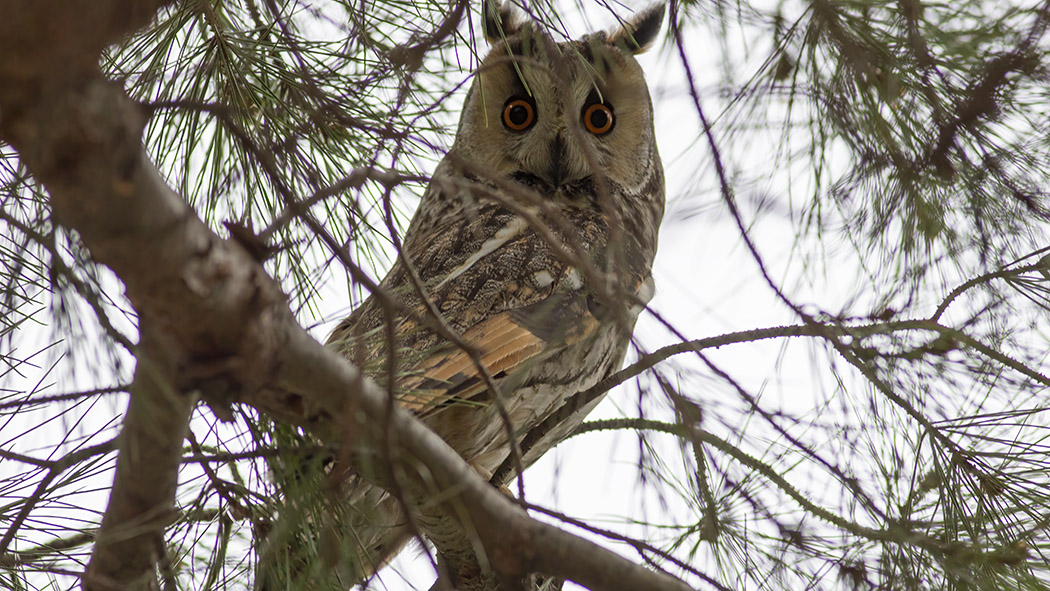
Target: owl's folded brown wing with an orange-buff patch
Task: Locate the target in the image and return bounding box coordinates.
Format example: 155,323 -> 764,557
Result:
330,204 -> 643,415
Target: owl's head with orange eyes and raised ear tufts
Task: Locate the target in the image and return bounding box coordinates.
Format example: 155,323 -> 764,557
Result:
452,2 -> 664,201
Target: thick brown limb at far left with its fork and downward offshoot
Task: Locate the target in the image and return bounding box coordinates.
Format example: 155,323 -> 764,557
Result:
0,0 -> 300,589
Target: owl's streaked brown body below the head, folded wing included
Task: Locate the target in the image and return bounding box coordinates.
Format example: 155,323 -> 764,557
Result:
327,191 -> 651,461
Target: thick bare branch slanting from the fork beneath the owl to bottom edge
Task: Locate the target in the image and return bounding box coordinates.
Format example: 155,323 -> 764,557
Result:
266,330 -> 689,590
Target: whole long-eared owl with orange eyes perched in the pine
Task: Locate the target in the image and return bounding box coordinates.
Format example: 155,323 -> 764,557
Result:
257,4 -> 664,589
